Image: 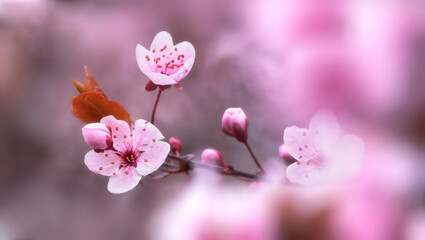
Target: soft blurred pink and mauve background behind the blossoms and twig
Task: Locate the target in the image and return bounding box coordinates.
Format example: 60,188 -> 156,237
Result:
0,0 -> 425,240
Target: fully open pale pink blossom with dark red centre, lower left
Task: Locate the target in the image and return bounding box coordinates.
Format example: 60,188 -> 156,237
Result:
84,116 -> 170,193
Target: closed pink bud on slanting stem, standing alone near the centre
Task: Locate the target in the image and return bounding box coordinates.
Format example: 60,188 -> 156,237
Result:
221,108 -> 248,142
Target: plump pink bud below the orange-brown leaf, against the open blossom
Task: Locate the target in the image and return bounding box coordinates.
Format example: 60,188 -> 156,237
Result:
82,123 -> 112,151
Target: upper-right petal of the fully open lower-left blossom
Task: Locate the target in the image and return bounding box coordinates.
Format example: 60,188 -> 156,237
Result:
133,119 -> 164,151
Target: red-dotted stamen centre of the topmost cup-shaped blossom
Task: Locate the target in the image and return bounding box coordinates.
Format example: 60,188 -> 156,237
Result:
145,45 -> 185,76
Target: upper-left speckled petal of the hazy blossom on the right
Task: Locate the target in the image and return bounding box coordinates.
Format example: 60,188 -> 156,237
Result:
283,126 -> 318,162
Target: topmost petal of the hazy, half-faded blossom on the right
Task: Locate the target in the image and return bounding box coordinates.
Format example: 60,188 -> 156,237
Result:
310,109 -> 339,142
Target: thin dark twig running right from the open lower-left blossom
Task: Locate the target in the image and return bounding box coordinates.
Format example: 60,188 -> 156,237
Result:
161,153 -> 260,181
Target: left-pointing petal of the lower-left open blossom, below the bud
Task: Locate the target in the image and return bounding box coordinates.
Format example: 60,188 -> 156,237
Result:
84,150 -> 120,176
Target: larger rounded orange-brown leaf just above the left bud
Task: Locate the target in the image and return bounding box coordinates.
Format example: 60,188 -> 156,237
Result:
71,92 -> 131,124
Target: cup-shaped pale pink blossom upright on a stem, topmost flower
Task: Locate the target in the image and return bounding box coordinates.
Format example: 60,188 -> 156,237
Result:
136,31 -> 195,85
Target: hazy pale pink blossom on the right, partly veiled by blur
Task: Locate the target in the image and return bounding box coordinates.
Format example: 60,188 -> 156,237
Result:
283,110 -> 364,185
